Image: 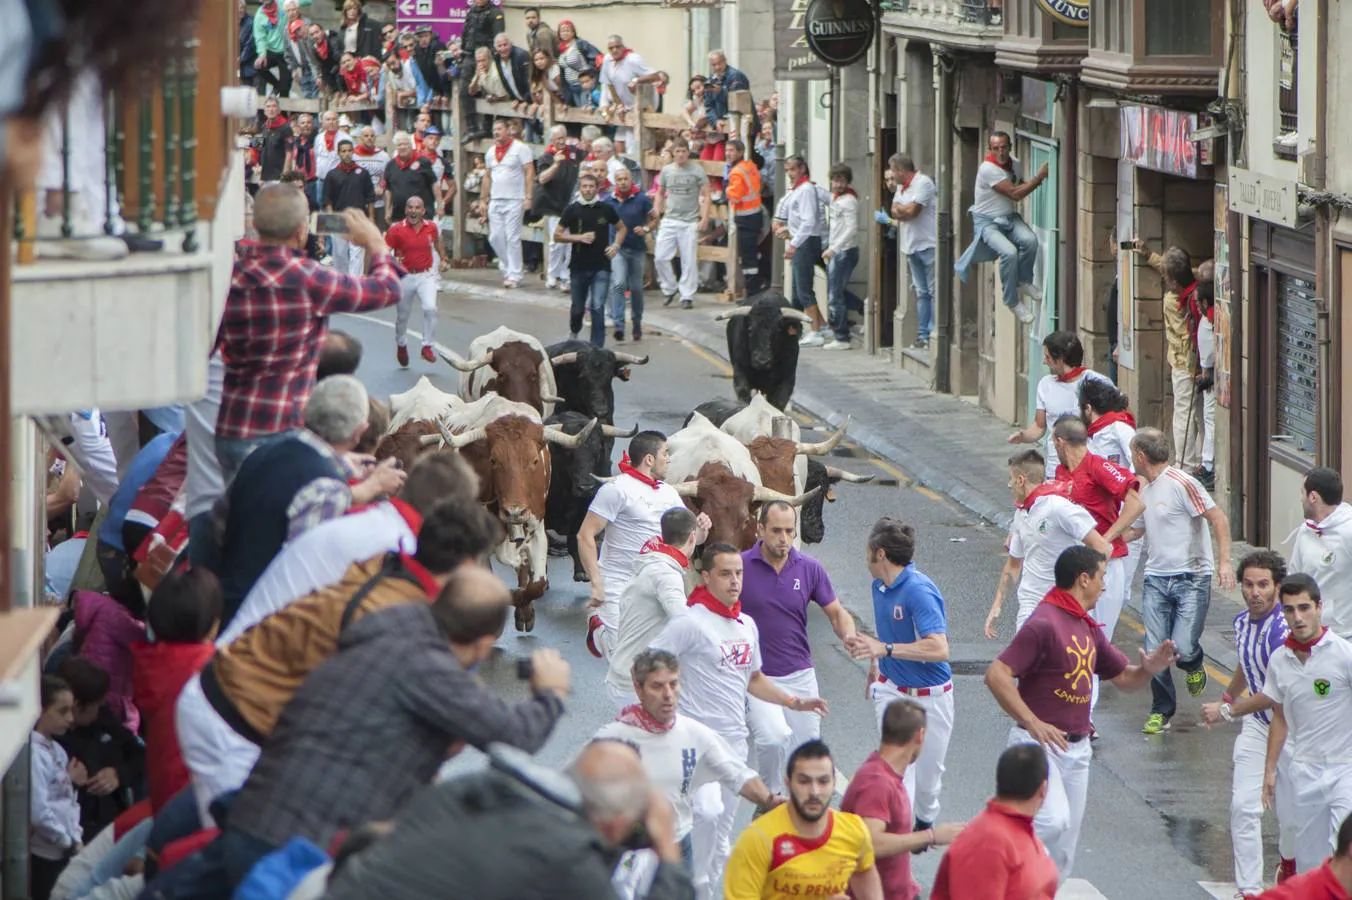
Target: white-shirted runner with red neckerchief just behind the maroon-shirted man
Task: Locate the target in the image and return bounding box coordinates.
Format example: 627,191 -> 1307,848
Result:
986,450 -> 1113,629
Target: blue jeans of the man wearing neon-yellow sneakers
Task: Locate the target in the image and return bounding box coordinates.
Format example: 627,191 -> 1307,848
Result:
1141,572 -> 1211,719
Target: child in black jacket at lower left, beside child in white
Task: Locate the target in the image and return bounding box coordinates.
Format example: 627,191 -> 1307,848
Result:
57,656 -> 146,835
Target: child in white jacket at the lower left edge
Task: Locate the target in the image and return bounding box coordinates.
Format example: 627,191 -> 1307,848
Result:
28,676 -> 85,900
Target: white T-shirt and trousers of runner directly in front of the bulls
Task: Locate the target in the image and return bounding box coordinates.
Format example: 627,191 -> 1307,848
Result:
587,474 -> 684,628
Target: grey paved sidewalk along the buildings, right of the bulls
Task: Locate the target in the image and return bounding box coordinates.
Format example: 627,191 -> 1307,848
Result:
442,269 -> 1248,674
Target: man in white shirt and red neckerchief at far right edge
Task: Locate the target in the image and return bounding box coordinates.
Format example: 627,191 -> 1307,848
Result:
1287,466 -> 1352,639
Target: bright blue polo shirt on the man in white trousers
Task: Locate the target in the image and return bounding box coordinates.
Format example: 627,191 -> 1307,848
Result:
873,564 -> 953,688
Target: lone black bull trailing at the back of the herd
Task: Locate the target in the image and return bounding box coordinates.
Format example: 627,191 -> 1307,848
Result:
718,292 -> 811,409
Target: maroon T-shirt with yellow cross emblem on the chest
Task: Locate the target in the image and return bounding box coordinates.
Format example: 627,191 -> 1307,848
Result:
996,591 -> 1129,735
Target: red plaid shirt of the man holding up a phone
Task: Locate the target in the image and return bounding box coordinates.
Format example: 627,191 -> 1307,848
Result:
216,245 -> 406,438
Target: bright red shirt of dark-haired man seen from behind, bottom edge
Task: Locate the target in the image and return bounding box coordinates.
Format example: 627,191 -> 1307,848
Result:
930,800 -> 1057,900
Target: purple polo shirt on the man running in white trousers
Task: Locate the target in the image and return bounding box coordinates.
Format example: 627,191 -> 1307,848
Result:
742,541 -> 836,677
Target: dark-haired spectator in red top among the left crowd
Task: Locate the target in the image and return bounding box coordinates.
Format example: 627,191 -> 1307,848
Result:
131,568 -> 220,812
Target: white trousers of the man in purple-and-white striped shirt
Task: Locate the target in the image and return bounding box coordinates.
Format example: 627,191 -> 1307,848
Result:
1230,716 -> 1295,895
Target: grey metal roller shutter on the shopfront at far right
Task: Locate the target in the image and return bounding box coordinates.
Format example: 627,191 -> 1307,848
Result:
1275,273 -> 1318,454
